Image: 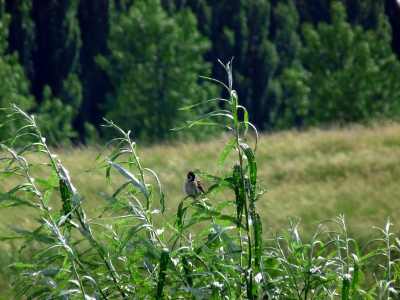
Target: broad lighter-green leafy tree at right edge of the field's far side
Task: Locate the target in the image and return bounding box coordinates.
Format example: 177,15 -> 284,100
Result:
283,2 -> 400,125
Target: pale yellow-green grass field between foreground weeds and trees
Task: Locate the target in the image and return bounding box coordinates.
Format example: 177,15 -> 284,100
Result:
0,124 -> 400,299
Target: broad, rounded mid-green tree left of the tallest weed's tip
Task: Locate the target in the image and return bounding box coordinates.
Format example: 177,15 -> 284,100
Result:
97,0 -> 219,141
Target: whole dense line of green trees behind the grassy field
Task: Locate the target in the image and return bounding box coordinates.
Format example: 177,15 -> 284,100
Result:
0,0 -> 400,144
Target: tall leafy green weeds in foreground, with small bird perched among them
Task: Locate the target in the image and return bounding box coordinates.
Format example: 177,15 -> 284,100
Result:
0,62 -> 400,299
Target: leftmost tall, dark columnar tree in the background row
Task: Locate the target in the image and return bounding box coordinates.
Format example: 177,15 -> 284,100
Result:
30,0 -> 82,144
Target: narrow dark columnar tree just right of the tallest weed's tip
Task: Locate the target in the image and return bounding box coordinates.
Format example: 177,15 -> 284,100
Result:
234,0 -> 281,129
